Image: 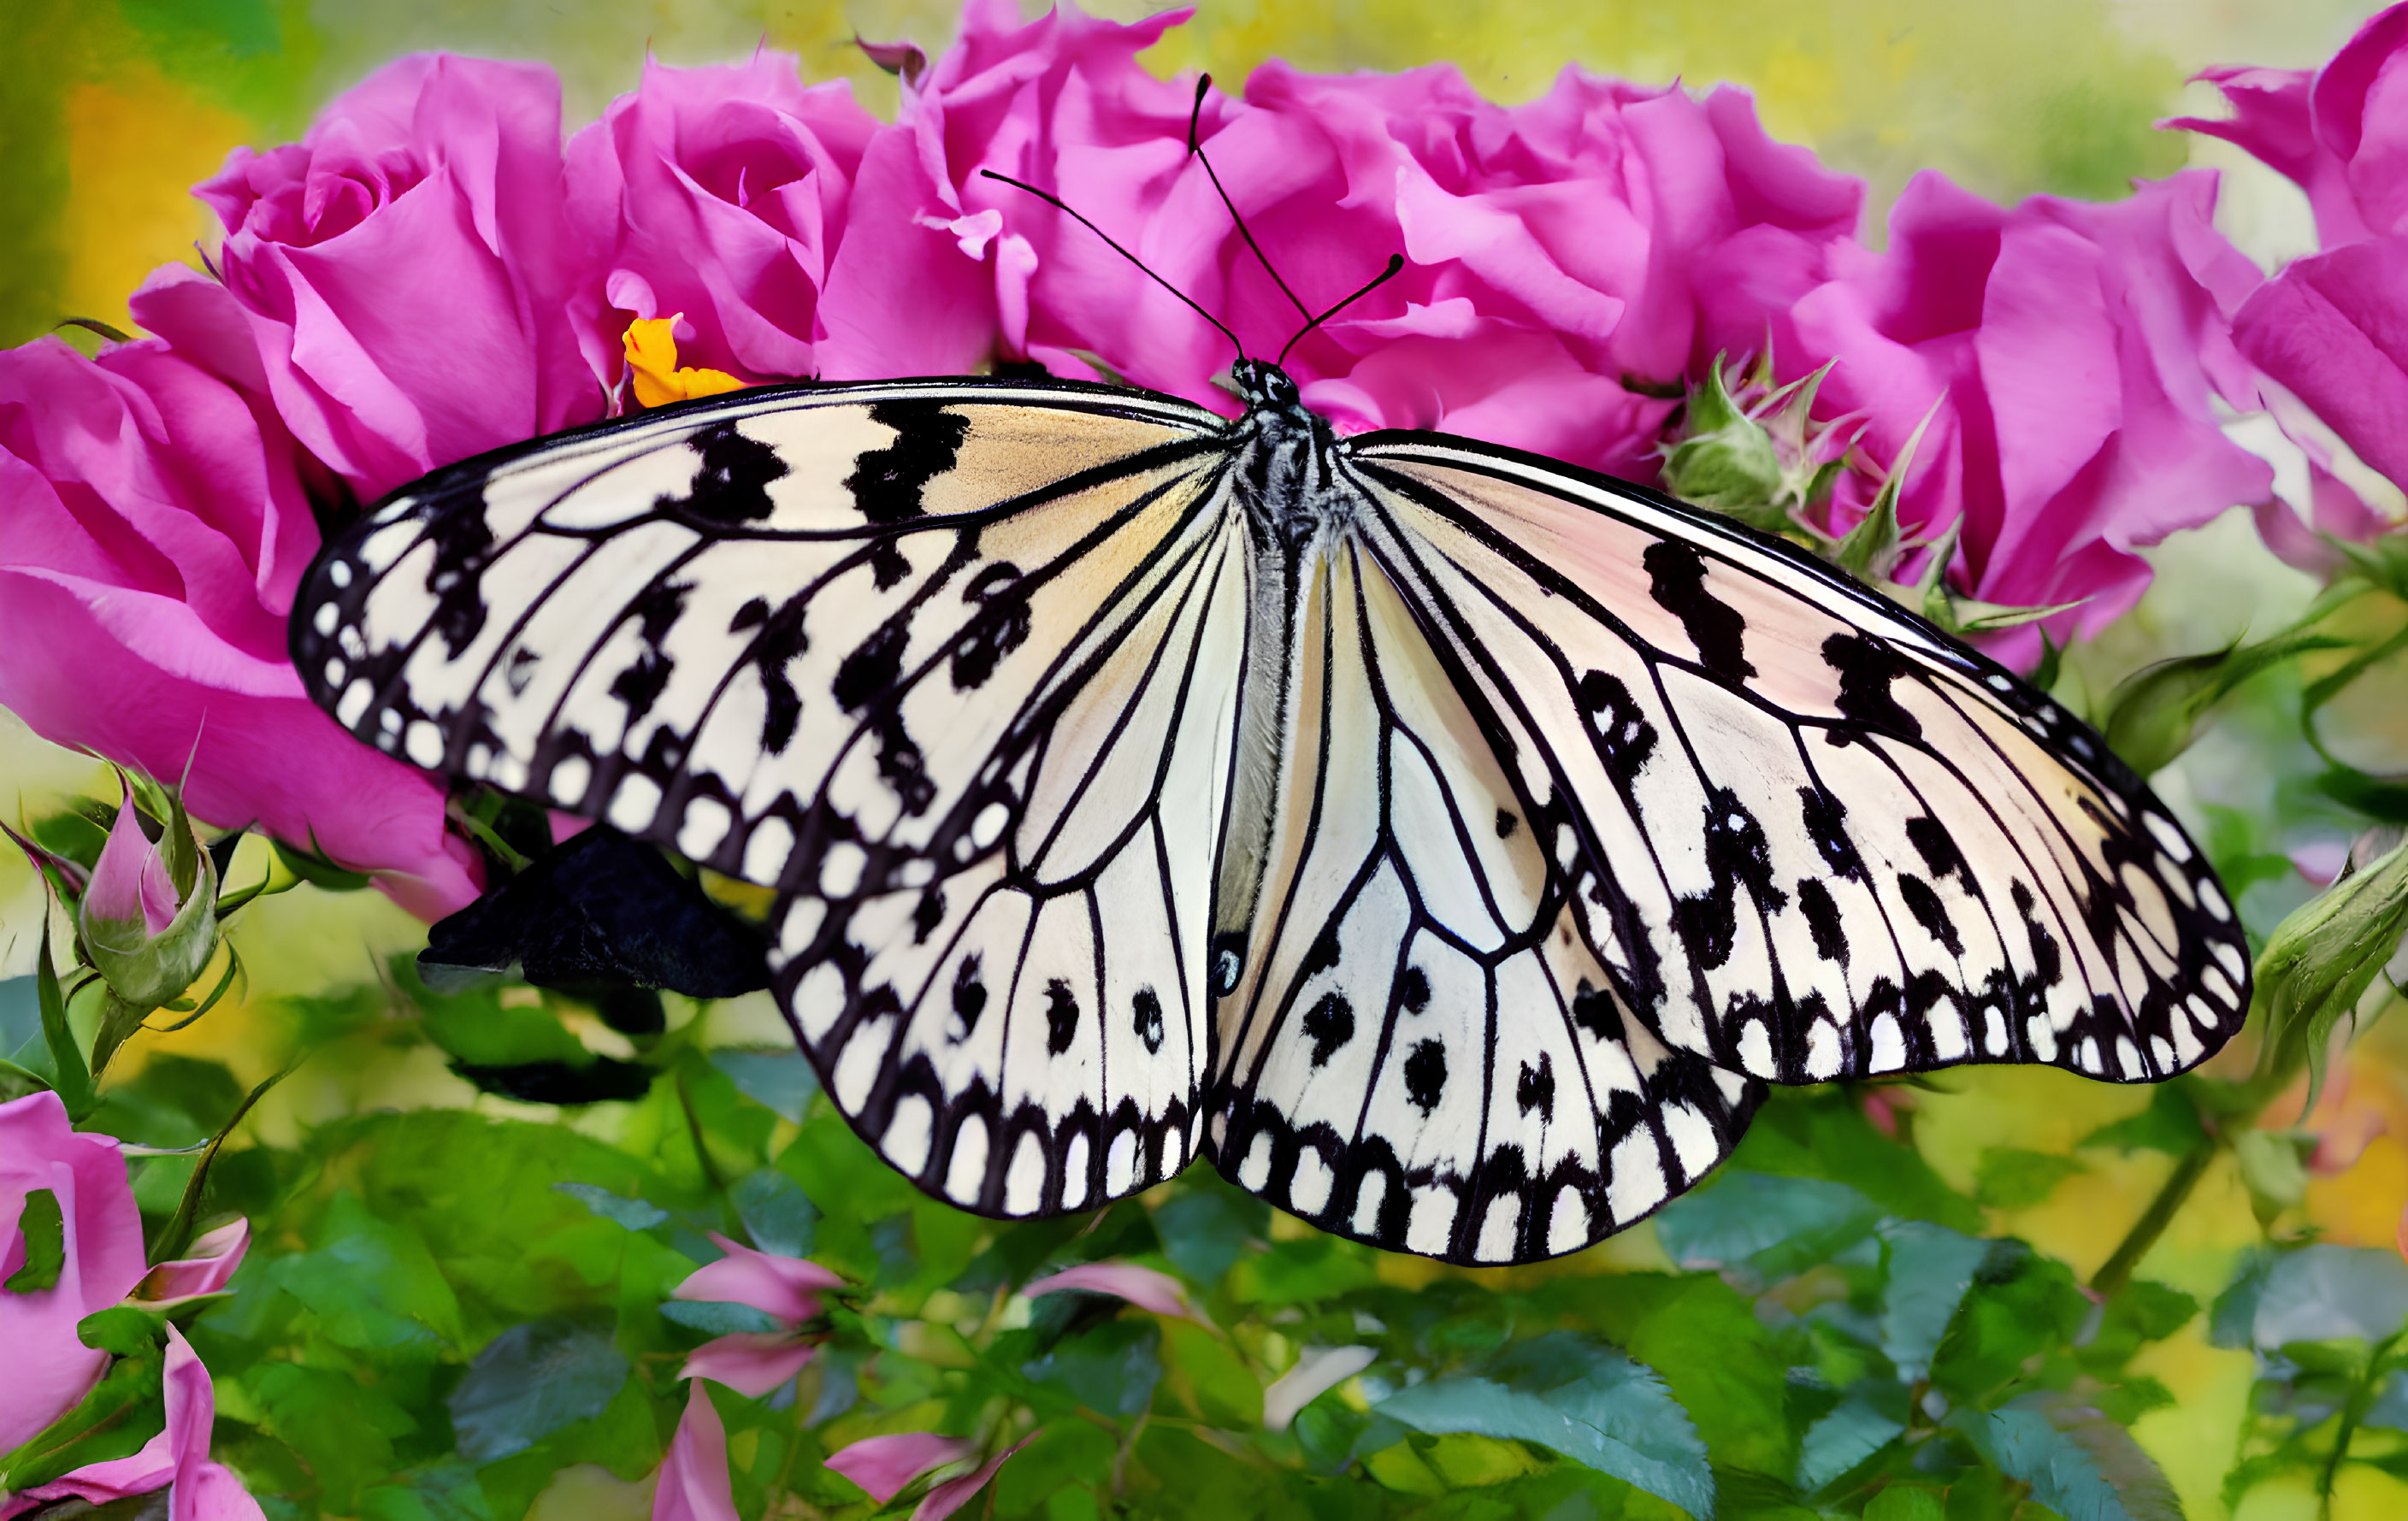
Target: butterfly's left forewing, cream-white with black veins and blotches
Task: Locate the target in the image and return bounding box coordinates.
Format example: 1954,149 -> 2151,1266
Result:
294,383 -> 1221,898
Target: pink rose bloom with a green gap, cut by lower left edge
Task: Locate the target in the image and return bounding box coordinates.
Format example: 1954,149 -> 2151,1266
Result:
0,1093 -> 145,1451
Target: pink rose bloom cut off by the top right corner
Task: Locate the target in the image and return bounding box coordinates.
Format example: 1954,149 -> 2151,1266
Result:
2167,5 -> 2408,520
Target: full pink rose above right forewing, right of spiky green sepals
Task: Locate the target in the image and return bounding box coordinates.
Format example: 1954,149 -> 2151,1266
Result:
1762,171 -> 2273,647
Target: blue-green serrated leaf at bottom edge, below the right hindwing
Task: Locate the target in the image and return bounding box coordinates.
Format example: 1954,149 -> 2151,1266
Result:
1375,1331 -> 1715,1516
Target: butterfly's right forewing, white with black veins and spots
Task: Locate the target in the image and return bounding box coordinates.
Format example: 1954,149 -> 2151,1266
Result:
1355,435 -> 2249,1083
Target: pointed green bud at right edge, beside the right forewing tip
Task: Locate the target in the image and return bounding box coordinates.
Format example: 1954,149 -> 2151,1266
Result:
2249,840 -> 2408,1114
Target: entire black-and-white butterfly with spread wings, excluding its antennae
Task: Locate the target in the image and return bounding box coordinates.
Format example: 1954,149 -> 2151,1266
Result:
294,363 -> 2246,1261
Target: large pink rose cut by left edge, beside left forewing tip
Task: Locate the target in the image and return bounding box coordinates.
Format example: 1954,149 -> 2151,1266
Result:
0,265 -> 477,917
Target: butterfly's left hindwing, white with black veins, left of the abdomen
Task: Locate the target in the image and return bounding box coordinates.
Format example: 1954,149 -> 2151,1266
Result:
770,498 -> 1245,1217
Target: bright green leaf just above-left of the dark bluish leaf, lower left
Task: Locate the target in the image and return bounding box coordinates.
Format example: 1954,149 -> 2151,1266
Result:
272,1194 -> 463,1355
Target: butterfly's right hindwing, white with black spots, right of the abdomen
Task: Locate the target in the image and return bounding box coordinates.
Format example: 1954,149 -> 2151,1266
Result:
1211,541 -> 1760,1264
